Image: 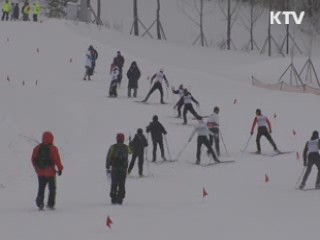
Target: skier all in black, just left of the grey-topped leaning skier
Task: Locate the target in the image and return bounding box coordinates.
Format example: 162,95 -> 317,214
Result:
146,115 -> 167,162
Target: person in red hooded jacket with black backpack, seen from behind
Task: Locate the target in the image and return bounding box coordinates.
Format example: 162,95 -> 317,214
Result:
31,132 -> 63,210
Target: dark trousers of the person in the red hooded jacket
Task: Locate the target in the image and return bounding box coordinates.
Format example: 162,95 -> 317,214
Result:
36,176 -> 56,207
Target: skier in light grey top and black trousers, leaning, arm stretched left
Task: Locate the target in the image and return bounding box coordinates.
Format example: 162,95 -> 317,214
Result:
189,116 -> 220,164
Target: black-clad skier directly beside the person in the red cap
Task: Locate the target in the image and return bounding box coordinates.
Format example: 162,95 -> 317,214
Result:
128,128 -> 148,177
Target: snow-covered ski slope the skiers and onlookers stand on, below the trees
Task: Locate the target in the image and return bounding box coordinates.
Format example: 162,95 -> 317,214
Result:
0,20 -> 319,240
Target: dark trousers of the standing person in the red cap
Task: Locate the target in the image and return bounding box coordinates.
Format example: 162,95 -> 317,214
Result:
110,169 -> 127,204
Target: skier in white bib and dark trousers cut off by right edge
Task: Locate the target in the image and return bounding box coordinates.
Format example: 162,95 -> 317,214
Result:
299,131 -> 320,189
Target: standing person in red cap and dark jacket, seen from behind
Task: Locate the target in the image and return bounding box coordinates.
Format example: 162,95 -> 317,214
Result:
106,133 -> 129,205
